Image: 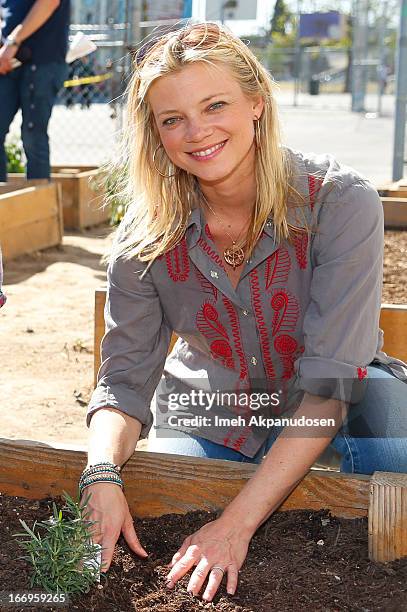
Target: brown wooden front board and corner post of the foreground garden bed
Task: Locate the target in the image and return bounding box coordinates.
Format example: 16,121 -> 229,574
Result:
0,438 -> 407,561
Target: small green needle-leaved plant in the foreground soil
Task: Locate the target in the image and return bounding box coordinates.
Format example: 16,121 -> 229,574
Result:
13,492 -> 101,595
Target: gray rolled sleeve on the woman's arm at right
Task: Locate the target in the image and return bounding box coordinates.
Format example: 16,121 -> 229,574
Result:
295,180 -> 384,403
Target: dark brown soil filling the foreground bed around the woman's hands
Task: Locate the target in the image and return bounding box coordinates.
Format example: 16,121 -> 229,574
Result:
0,494 -> 407,612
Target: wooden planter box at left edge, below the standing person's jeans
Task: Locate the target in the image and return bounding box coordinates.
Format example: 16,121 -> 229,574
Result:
0,183 -> 63,261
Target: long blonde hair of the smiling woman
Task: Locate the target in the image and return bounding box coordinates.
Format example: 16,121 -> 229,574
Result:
113,22 -> 300,261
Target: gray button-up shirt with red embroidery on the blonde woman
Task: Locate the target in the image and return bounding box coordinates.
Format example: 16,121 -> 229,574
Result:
87,150 -> 407,457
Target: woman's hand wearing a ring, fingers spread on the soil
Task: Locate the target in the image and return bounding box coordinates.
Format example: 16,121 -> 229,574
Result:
167,518 -> 251,601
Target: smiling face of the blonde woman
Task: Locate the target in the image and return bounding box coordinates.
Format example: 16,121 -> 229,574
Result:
148,62 -> 264,184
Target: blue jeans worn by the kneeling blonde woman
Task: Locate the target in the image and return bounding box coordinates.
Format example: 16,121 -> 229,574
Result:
148,364 -> 407,474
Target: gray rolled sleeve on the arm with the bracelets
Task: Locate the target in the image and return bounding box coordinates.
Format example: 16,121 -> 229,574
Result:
86,258 -> 171,438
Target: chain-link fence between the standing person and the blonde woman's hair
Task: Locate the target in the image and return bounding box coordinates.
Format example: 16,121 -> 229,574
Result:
7,13 -> 128,166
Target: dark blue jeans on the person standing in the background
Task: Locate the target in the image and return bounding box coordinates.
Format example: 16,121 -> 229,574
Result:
0,62 -> 67,182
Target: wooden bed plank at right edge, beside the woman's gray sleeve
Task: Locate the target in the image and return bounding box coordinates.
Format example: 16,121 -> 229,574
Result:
380,304 -> 407,361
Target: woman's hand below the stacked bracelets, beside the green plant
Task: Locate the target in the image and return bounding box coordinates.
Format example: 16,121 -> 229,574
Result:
82,482 -> 148,572
